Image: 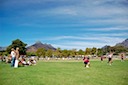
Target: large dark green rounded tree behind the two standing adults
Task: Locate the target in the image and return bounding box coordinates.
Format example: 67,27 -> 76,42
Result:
6,39 -> 27,55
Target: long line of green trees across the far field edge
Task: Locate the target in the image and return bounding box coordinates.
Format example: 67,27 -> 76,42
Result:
0,39 -> 128,58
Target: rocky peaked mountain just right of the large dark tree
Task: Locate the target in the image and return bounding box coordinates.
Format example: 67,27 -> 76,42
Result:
27,41 -> 56,52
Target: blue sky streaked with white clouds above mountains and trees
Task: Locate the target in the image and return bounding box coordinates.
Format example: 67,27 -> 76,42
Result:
0,0 -> 128,50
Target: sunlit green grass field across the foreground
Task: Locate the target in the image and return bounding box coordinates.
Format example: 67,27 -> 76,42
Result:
0,60 -> 128,85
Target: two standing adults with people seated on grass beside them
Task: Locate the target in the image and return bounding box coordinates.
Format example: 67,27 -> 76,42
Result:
11,47 -> 36,68
